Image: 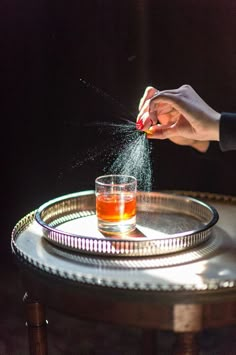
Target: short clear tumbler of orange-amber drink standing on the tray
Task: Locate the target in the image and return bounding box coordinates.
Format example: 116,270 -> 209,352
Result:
95,175 -> 137,234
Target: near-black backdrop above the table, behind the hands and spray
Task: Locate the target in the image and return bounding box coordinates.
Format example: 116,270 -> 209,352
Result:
0,0 -> 236,259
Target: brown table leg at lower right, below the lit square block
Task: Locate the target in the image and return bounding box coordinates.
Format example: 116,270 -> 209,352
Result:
173,333 -> 199,355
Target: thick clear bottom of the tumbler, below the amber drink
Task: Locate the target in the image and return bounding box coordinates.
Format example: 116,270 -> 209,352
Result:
98,217 -> 136,234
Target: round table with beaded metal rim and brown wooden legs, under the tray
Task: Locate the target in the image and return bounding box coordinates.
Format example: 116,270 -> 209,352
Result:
12,191 -> 236,355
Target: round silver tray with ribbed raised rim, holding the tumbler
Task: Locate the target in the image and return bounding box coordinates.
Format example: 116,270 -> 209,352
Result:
35,191 -> 218,257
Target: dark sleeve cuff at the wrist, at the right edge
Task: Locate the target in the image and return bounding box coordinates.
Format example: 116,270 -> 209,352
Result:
220,112 -> 236,152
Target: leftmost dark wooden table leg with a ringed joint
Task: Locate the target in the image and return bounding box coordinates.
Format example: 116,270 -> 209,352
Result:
23,293 -> 48,355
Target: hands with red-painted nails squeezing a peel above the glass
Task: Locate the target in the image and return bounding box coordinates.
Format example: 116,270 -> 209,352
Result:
136,85 -> 220,152
